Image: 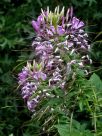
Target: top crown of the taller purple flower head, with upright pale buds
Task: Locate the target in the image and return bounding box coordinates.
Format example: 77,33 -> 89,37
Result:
32,7 -> 90,51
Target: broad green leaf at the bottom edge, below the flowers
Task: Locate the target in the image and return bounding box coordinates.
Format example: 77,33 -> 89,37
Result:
54,118 -> 93,136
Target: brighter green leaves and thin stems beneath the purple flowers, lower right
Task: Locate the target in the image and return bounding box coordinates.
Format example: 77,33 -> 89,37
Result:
16,73 -> 102,136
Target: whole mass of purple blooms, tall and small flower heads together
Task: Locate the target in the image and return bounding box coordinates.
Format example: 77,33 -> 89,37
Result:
19,7 -> 91,111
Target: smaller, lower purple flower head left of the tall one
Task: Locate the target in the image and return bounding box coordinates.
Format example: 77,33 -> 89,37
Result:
18,61 -> 47,111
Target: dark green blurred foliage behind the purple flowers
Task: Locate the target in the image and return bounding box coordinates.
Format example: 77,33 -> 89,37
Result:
0,0 -> 102,136
